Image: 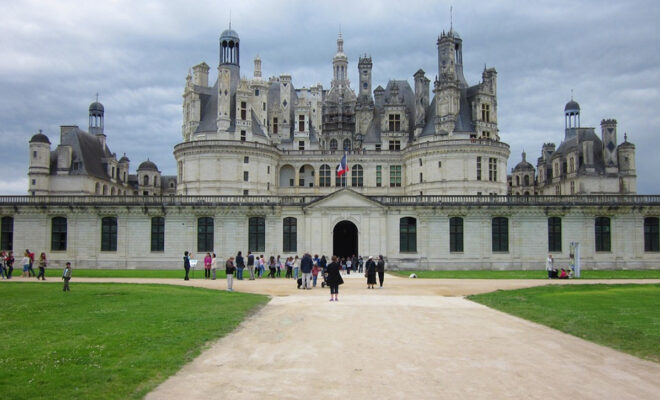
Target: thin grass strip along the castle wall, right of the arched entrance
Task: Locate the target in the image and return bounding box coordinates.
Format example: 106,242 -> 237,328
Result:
388,269 -> 660,279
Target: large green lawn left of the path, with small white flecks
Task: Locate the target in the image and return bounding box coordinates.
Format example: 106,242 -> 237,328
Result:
0,279 -> 268,399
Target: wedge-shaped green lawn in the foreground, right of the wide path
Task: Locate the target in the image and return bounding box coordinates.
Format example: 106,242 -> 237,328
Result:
468,284 -> 660,362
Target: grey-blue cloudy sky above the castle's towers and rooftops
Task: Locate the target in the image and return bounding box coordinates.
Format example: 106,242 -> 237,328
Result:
0,0 -> 660,194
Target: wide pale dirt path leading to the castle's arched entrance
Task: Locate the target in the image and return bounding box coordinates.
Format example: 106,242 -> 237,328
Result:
135,276 -> 660,399
